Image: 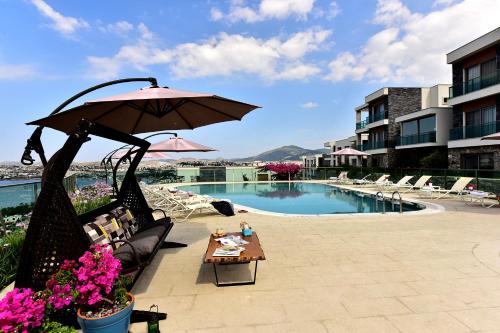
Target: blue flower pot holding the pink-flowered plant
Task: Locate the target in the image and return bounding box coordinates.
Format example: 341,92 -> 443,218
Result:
77,293 -> 135,333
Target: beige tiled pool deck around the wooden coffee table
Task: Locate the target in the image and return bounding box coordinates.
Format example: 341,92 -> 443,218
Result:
131,183 -> 500,333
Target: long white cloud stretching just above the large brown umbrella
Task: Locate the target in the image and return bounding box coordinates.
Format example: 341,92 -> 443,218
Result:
87,24 -> 331,81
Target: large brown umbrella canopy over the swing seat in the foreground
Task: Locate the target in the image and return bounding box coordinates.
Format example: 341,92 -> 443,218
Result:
28,87 -> 258,134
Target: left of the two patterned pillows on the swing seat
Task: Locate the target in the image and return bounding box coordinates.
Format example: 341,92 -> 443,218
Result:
83,214 -> 126,249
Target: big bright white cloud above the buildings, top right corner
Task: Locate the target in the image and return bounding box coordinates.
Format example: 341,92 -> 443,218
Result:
326,0 -> 500,84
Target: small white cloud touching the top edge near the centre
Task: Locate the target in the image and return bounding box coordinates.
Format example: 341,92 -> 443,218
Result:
210,0 -> 316,23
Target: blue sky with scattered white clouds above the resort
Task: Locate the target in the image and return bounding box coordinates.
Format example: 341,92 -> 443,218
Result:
0,0 -> 500,161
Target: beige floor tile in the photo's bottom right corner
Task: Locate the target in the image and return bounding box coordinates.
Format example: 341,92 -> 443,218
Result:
450,307 -> 500,331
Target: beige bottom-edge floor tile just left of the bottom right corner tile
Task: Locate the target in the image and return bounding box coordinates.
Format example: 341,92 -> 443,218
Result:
388,312 -> 470,333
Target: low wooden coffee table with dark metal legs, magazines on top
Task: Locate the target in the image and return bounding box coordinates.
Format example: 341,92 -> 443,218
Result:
203,232 -> 266,287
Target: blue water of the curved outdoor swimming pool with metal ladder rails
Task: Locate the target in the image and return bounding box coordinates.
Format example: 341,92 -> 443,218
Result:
179,182 -> 425,215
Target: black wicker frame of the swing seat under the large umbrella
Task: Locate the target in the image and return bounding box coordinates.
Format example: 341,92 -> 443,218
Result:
15,120 -> 186,322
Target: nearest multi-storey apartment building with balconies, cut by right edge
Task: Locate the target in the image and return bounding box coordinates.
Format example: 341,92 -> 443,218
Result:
447,28 -> 500,169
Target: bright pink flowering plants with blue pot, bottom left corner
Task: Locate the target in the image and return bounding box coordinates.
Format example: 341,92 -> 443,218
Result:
0,245 -> 134,333
